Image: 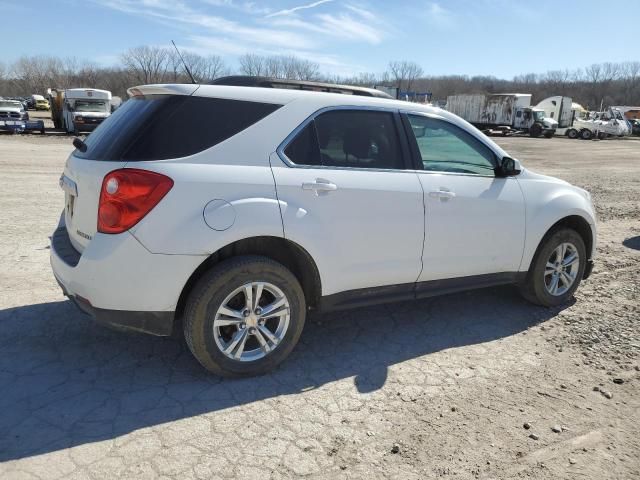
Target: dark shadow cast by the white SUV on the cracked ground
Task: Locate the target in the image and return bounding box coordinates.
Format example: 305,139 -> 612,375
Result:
0,287 -> 559,462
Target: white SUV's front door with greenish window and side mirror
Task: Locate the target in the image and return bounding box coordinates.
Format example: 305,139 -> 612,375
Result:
404,113 -> 525,282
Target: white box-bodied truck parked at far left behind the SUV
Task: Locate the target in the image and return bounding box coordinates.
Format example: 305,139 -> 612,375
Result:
48,88 -> 111,135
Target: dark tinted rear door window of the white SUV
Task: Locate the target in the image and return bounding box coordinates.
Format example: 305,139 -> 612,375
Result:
285,110 -> 404,169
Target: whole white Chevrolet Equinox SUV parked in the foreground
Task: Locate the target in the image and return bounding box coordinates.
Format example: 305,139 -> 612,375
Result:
51,80 -> 596,376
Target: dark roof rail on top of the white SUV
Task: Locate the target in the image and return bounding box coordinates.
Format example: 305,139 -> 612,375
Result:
209,75 -> 393,98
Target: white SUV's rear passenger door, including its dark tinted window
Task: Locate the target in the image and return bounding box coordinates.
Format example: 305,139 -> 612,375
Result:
271,107 -> 424,295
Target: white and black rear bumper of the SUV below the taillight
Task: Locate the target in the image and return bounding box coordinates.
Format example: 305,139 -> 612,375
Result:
50,217 -> 204,335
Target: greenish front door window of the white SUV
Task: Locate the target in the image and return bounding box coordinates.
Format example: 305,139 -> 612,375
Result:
409,115 -> 494,175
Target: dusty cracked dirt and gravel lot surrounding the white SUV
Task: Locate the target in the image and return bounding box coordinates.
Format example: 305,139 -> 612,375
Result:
0,130 -> 640,479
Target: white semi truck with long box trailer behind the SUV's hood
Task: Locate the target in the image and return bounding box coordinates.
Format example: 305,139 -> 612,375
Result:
446,93 -> 558,138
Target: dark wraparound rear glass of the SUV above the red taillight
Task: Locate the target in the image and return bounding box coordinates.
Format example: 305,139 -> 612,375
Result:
74,95 -> 281,162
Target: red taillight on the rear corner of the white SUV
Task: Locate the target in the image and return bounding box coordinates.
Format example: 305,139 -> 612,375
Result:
98,168 -> 173,233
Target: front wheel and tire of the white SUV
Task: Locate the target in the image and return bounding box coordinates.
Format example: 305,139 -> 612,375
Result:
520,228 -> 587,307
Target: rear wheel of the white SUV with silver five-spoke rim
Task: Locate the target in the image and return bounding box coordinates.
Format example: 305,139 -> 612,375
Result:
184,256 -> 306,377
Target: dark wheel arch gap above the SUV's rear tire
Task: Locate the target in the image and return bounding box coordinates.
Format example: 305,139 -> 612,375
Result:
174,236 -> 322,331
